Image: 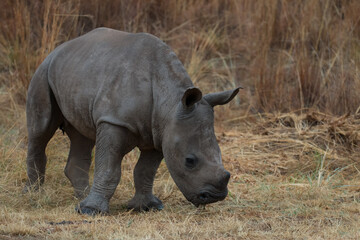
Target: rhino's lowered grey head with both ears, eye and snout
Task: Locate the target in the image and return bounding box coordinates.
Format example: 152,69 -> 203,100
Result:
162,87 -> 240,206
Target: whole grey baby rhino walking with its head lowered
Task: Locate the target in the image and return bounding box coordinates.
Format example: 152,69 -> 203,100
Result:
24,28 -> 239,215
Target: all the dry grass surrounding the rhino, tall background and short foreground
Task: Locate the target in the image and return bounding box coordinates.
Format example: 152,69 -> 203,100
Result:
0,0 -> 360,239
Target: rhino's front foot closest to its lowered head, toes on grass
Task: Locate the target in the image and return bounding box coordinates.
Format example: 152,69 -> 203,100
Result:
127,194 -> 164,211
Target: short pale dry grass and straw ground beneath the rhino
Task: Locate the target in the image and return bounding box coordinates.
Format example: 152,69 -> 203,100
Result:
0,101 -> 360,239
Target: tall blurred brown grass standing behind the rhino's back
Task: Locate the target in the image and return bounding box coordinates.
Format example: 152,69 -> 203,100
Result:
0,0 -> 360,115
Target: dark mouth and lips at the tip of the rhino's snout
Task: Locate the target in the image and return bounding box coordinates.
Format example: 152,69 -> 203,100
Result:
191,187 -> 228,207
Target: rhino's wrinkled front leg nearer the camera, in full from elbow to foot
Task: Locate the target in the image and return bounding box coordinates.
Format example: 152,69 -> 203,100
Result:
76,123 -> 137,215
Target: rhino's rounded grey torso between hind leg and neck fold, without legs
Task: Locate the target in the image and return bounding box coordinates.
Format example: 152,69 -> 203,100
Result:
48,28 -> 171,143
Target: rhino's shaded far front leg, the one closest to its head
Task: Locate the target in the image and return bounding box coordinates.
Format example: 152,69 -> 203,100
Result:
128,150 -> 163,211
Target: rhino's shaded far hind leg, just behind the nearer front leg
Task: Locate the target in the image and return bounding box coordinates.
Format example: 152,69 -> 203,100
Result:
63,122 -> 95,199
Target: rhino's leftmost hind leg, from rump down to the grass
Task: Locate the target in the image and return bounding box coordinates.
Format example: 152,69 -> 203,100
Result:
23,63 -> 63,192
